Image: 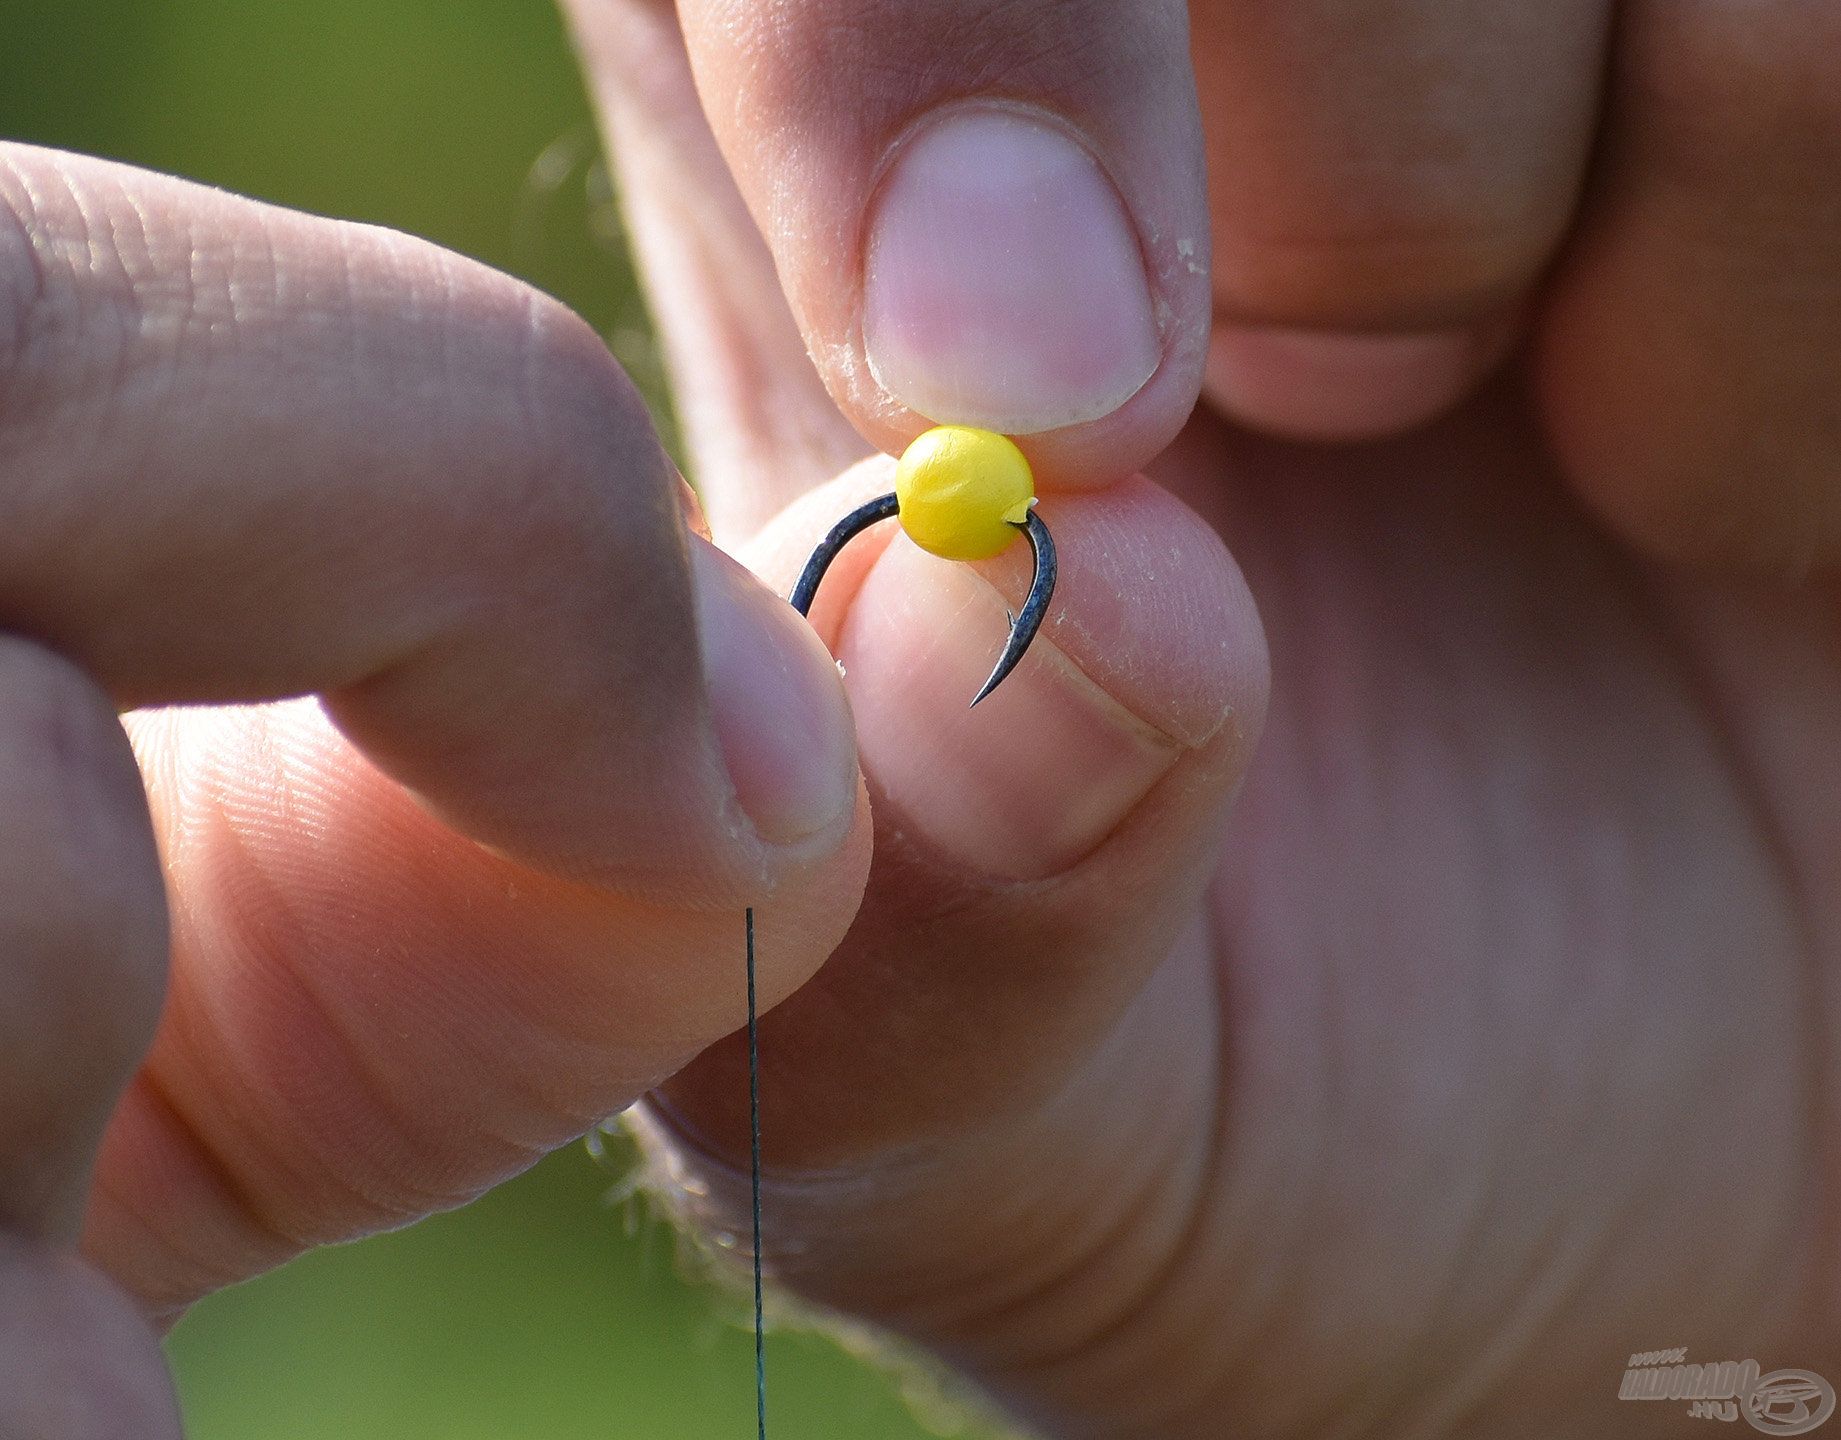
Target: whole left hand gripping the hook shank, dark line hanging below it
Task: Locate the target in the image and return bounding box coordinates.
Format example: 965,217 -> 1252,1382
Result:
0,147 -> 869,1440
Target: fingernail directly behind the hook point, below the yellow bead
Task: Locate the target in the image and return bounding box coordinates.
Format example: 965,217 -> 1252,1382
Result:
839,538 -> 1182,880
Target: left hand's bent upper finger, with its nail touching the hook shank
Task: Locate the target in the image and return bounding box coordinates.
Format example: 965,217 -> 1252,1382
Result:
0,140 -> 854,900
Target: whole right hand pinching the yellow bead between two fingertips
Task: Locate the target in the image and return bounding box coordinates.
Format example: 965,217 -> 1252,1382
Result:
573,0 -> 1841,1440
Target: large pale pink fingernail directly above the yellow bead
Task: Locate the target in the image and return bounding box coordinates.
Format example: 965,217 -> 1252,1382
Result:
863,109 -> 1160,435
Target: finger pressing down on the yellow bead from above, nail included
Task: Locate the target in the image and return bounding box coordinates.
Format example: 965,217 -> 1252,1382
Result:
576,0 -> 1208,484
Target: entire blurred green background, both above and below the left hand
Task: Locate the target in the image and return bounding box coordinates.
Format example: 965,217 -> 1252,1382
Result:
0,0 -> 994,1440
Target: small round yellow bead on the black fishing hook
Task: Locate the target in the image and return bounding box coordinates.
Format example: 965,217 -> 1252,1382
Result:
895,425 -> 1035,560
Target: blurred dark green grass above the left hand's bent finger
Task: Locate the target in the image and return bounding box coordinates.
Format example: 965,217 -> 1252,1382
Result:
0,0 -> 670,431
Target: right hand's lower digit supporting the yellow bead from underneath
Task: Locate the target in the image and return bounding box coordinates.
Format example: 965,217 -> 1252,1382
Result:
655,464 -> 1267,1352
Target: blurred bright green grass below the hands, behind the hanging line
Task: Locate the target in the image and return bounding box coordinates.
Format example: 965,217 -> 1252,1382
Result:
169,1147 -> 964,1440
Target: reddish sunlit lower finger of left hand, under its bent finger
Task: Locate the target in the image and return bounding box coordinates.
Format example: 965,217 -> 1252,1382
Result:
85,699 -> 869,1315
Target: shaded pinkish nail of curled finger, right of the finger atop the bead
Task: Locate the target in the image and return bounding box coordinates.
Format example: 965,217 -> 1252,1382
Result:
1206,326 -> 1500,440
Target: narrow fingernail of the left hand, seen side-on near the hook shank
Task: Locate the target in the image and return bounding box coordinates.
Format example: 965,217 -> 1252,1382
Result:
690,540 -> 856,845
